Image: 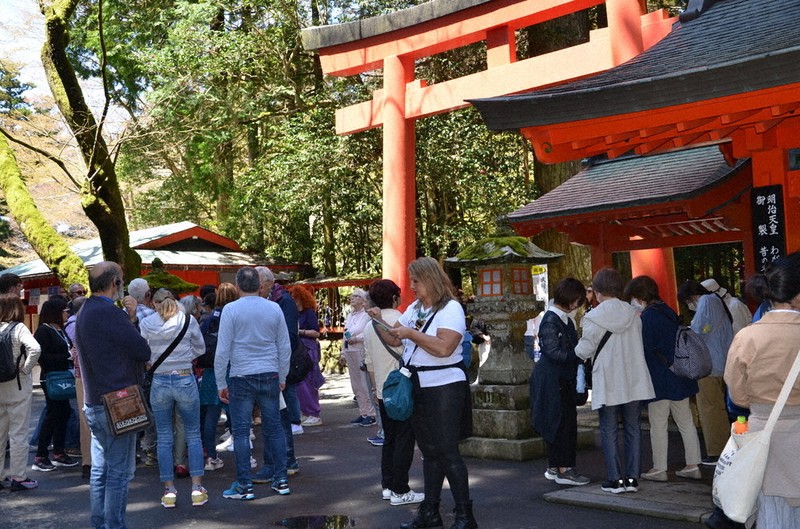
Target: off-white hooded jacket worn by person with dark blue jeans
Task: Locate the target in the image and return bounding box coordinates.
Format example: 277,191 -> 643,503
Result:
575,298 -> 656,410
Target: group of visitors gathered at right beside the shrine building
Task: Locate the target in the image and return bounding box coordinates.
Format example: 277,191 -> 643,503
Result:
530,253 -> 800,529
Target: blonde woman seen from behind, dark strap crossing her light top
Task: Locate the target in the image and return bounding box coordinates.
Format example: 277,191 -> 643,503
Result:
139,288 -> 208,508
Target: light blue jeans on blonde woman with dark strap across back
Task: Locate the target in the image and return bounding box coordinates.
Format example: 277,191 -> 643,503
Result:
150,373 -> 205,481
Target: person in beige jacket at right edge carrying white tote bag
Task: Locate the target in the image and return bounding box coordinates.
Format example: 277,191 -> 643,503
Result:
715,252 -> 800,529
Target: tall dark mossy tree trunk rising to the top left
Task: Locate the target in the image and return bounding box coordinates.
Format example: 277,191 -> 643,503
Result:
39,0 -> 141,277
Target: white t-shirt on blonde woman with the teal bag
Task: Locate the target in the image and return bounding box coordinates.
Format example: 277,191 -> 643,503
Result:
398,300 -> 467,388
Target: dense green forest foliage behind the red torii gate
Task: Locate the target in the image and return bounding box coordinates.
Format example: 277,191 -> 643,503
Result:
72,0 -> 533,275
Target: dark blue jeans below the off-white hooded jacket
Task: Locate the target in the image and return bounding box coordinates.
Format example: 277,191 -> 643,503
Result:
597,400 -> 642,481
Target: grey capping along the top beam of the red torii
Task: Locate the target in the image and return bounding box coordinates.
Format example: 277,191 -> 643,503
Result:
301,0 -> 492,50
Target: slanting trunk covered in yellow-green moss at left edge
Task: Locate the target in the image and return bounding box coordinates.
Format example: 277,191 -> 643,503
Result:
0,134 -> 89,288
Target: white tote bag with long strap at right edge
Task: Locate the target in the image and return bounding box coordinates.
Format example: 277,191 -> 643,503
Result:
711,344 -> 800,523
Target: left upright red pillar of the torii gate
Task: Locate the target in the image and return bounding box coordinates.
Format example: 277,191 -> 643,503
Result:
383,57 -> 417,307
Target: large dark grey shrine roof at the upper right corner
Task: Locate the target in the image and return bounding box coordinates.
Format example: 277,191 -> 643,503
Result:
470,0 -> 800,130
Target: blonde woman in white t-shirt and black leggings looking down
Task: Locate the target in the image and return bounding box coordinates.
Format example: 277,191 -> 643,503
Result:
369,257 -> 478,529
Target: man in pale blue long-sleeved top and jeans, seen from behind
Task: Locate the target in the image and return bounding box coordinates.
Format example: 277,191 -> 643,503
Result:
214,266 -> 292,500
